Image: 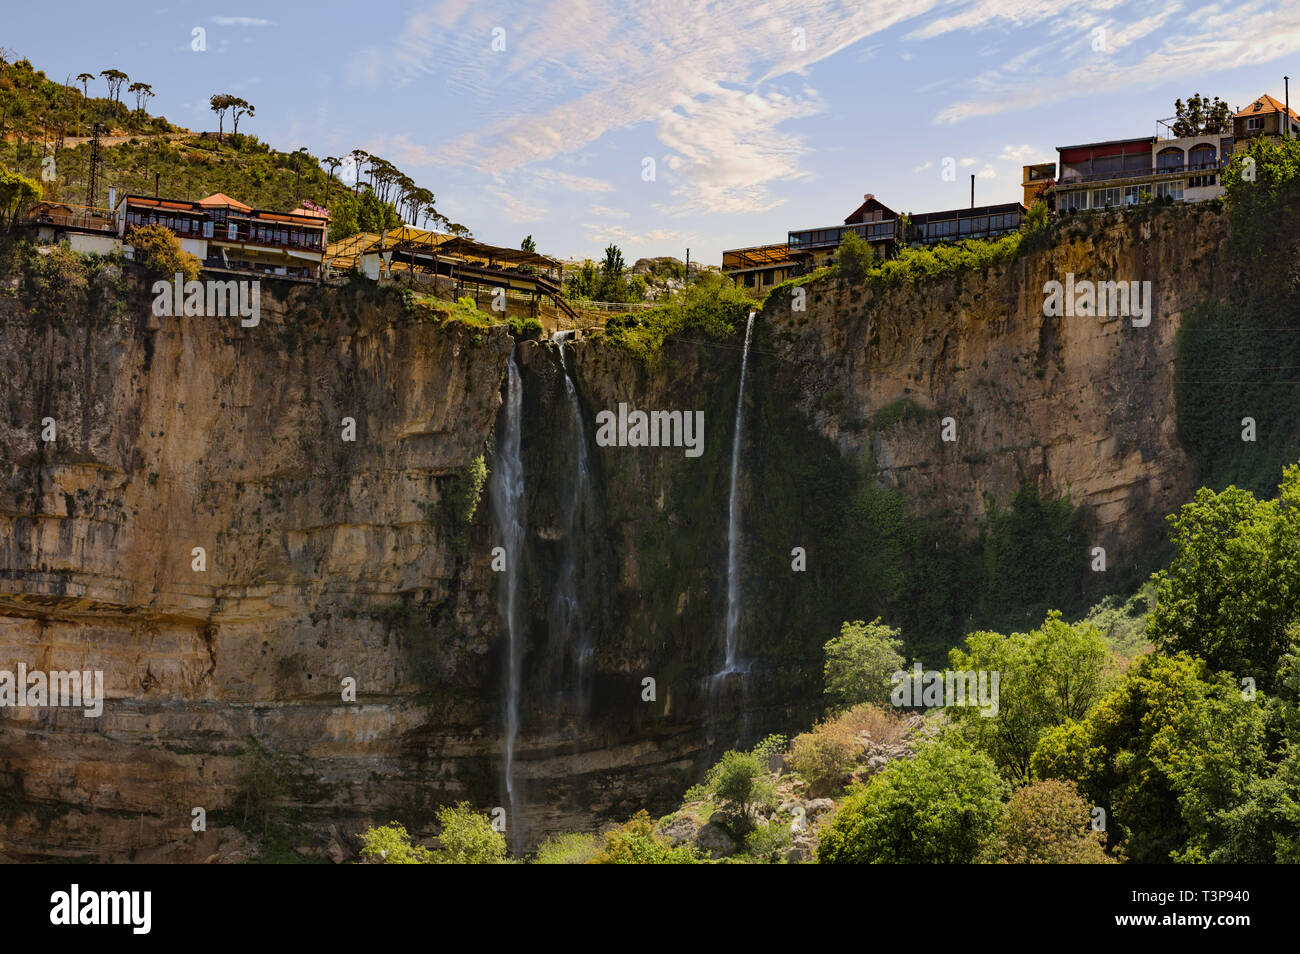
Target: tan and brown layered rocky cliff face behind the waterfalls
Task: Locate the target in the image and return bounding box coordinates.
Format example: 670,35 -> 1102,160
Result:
0,212 -> 1225,860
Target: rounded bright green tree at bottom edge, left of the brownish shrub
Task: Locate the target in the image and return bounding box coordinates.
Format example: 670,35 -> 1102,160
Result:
816,736 -> 1008,864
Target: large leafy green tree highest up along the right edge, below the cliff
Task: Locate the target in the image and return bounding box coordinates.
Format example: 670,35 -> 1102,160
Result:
1147,465 -> 1300,690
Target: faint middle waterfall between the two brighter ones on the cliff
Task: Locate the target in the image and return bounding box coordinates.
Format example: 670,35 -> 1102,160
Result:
551,331 -> 593,704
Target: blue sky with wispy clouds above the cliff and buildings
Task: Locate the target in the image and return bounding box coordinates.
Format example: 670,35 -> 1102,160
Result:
10,0 -> 1300,264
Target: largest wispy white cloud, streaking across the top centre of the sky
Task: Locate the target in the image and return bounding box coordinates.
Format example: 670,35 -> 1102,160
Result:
348,0 -> 940,213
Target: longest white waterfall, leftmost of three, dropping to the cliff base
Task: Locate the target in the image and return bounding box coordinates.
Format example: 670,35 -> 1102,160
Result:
490,348 -> 524,851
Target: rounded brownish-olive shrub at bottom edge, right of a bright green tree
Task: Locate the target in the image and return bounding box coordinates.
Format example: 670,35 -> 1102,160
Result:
998,780 -> 1115,864
